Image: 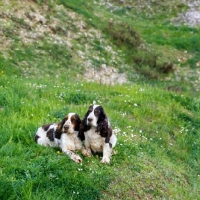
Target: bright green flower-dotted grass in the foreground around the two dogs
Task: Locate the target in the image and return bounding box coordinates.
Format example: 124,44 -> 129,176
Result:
0,75 -> 200,199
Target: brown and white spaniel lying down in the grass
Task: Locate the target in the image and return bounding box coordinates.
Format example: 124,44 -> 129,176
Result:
35,113 -> 83,162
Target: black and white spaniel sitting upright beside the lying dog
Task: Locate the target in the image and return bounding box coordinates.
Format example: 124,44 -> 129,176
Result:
79,103 -> 117,164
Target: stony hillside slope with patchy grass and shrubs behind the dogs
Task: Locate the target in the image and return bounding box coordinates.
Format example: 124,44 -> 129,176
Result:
0,1 -> 200,93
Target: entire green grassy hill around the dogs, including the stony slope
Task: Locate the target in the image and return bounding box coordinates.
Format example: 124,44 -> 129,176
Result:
0,0 -> 200,200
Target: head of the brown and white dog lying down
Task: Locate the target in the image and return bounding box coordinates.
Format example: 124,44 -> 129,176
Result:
57,113 -> 81,134
